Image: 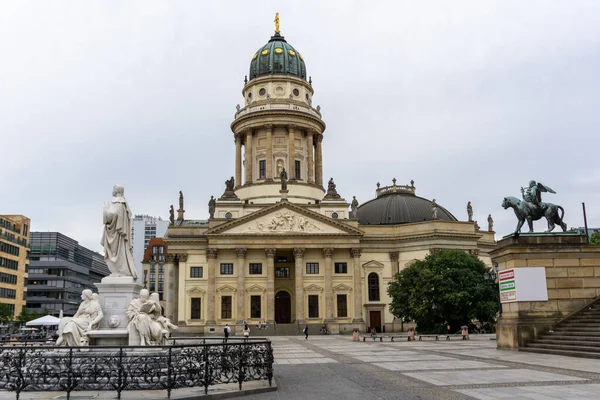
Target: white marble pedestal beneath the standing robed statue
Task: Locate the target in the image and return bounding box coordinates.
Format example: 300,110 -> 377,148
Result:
89,276 -> 142,346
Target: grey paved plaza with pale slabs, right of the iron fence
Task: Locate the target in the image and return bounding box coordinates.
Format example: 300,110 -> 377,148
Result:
247,335 -> 600,400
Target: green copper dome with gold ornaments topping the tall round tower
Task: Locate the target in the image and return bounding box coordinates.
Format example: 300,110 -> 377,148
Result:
250,33 -> 306,80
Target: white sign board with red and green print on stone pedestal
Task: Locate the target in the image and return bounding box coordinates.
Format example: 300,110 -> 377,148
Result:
498,267 -> 548,303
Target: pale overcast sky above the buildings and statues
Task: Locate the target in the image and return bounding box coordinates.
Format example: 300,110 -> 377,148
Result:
0,0 -> 600,251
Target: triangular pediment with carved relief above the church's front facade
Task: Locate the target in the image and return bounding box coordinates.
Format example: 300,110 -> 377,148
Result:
205,202 -> 362,236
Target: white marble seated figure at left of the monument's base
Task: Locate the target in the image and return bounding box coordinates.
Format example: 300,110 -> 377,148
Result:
56,289 -> 104,346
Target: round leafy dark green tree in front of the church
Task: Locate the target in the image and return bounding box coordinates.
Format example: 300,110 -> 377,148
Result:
388,249 -> 498,333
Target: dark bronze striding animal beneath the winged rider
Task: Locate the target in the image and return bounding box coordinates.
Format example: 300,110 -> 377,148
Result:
502,197 -> 567,234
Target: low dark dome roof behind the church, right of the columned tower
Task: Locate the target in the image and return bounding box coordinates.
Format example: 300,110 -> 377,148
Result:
358,192 -> 457,225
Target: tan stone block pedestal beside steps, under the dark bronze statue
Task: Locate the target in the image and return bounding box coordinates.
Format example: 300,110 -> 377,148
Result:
490,232 -> 600,349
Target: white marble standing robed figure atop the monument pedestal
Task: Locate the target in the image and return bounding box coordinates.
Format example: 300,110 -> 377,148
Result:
100,185 -> 137,280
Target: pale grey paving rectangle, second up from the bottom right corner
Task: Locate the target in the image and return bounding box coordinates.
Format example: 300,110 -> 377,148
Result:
404,369 -> 586,386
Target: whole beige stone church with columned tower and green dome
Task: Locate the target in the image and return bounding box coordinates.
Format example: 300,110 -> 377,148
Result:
164,22 -> 495,334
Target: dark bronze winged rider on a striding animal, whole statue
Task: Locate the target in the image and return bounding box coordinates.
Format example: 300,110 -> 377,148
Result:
502,181 -> 567,234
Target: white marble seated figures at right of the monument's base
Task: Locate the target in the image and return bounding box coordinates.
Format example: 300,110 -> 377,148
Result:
126,289 -> 177,346
